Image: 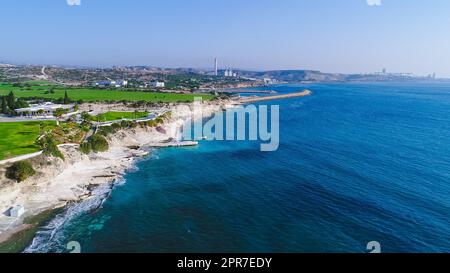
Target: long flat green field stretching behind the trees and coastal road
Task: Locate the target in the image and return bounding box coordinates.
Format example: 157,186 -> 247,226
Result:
0,84 -> 213,102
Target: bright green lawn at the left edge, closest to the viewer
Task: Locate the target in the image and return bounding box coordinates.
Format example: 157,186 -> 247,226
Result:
0,121 -> 56,160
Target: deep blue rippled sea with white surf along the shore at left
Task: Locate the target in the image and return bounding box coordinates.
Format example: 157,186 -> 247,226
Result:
23,83 -> 450,253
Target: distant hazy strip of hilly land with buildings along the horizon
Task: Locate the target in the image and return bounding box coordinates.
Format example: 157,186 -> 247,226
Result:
0,62 -> 442,85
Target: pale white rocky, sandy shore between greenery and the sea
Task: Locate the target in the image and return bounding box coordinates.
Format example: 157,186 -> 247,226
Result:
0,102 -> 226,246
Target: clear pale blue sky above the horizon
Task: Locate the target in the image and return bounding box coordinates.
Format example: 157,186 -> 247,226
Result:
0,0 -> 450,77
